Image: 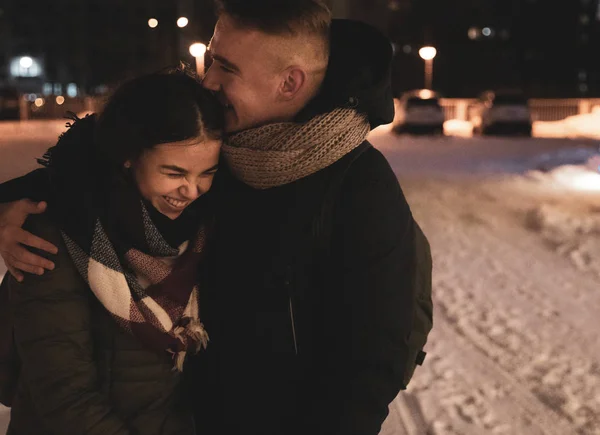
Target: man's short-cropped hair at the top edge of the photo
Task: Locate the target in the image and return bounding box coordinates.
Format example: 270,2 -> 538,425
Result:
215,0 -> 331,53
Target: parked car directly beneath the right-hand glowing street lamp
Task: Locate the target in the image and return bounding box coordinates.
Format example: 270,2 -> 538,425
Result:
393,89 -> 446,134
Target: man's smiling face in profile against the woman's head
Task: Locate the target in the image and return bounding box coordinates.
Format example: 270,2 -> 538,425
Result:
203,16 -> 283,133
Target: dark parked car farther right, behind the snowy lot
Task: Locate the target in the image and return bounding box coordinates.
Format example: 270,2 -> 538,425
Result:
470,91 -> 532,136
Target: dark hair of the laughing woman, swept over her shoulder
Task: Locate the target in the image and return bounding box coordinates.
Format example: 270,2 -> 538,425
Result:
38,67 -> 225,189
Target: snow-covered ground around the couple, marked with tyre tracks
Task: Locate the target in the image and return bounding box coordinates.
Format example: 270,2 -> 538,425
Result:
0,118 -> 600,435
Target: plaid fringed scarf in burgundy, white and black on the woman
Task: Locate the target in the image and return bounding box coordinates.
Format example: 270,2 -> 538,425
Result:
42,118 -> 208,371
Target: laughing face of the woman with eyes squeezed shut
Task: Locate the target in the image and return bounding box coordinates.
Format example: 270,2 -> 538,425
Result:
125,139 -> 221,219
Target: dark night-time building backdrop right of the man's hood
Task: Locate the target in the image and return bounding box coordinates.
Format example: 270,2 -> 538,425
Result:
339,0 -> 600,97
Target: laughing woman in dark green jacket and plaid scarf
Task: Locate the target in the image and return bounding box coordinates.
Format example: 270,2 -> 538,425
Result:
8,65 -> 223,435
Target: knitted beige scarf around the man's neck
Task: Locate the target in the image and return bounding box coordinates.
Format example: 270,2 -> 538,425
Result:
223,109 -> 370,189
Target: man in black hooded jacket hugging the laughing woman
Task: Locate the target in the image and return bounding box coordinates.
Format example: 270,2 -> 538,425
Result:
0,0 -> 431,435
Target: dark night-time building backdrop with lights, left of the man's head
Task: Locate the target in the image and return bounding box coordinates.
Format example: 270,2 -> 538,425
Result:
0,0 -> 214,95
